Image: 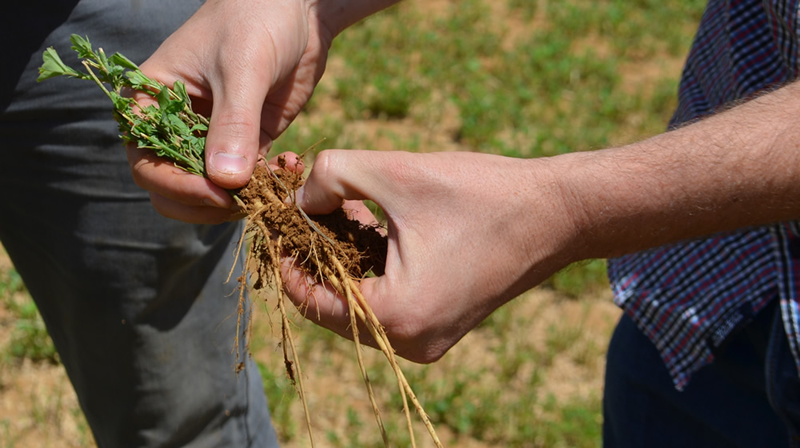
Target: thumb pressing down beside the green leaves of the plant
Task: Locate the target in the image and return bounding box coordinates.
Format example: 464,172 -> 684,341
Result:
206,74 -> 271,189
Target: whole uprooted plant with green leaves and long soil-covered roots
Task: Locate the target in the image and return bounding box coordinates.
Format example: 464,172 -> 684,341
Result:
38,35 -> 441,446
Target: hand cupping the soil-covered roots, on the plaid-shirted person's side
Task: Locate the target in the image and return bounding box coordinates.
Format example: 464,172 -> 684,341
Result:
283,151 -> 579,362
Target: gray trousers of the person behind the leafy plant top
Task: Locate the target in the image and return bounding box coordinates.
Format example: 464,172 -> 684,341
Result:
0,0 -> 277,447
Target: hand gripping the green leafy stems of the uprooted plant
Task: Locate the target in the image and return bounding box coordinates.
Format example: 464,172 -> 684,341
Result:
128,0 -> 333,223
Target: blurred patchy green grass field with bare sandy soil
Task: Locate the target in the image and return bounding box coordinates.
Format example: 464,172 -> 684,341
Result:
0,0 -> 704,447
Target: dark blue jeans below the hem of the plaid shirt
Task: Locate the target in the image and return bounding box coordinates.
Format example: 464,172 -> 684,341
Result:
603,300 -> 800,448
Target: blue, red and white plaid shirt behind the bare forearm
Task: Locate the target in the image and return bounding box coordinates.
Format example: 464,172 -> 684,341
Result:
608,0 -> 800,390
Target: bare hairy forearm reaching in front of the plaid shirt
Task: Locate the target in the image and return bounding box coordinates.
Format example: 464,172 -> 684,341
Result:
559,83 -> 800,258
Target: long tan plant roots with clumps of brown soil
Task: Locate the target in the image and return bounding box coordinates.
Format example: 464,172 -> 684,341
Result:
229,159 -> 442,447
